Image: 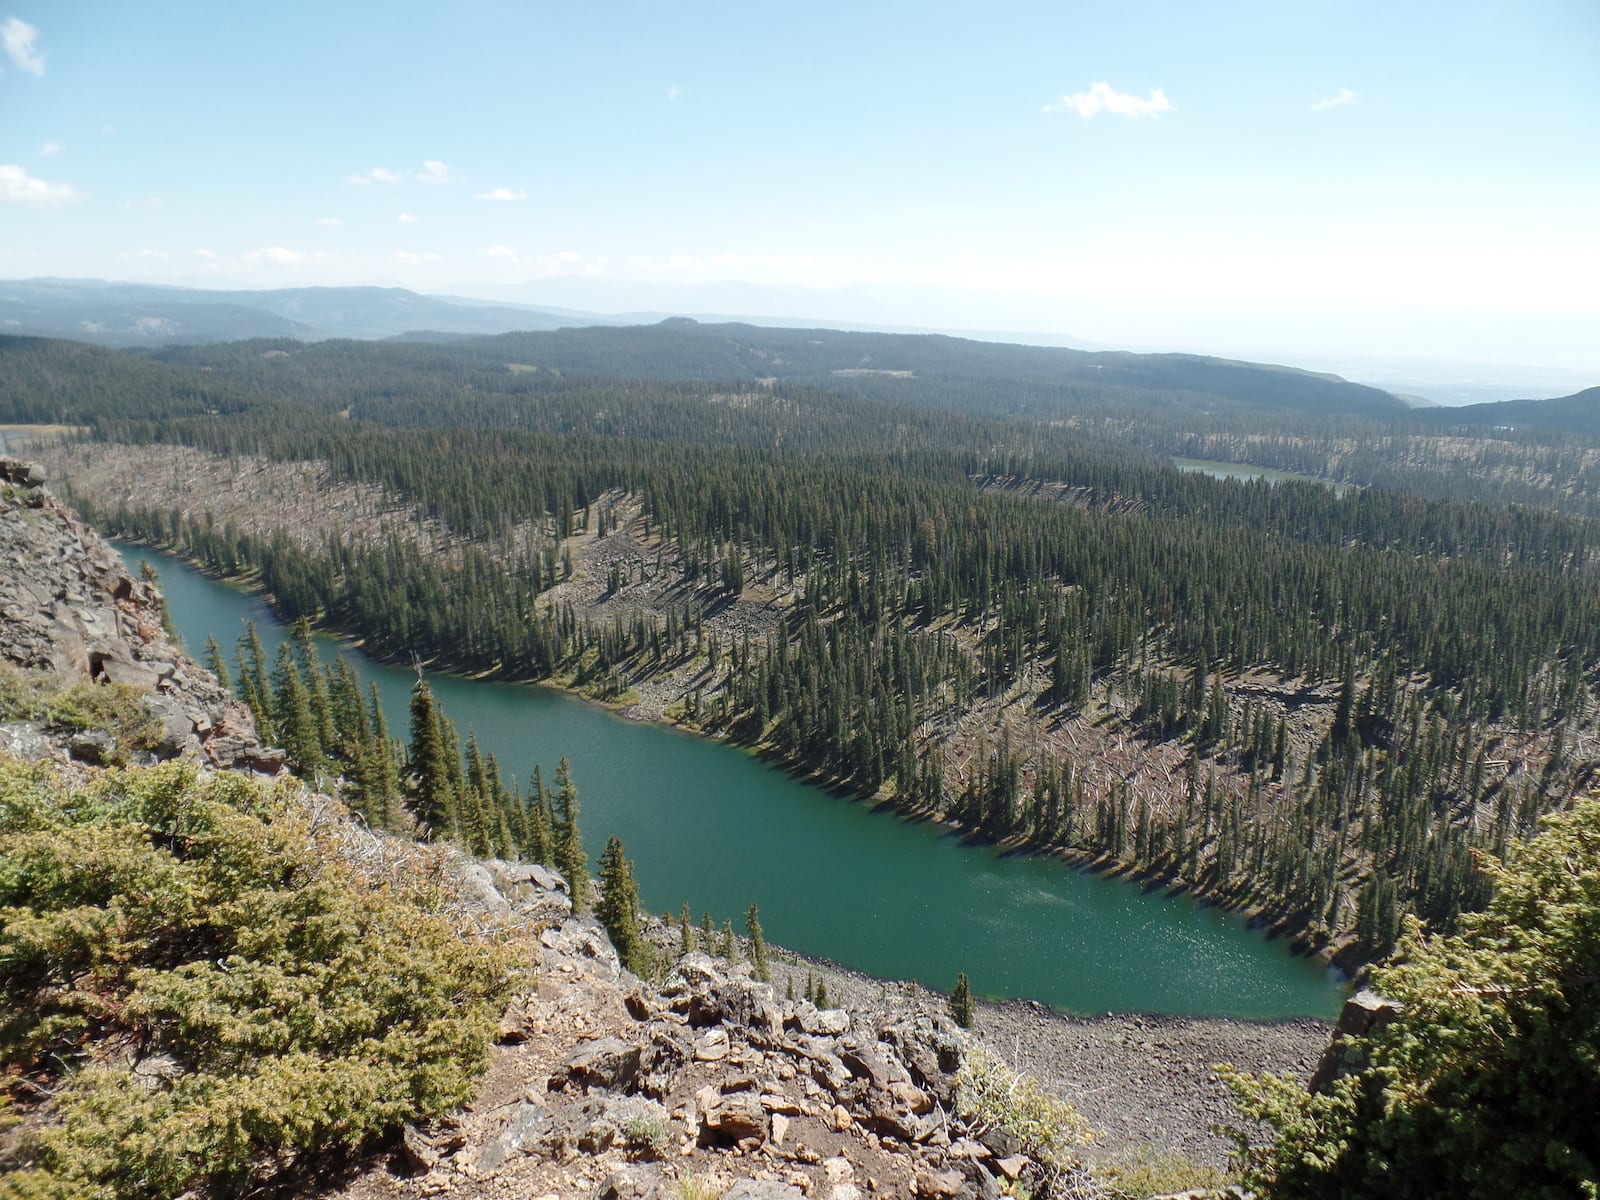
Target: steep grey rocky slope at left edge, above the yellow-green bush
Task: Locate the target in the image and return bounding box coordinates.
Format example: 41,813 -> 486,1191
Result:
0,458 -> 283,773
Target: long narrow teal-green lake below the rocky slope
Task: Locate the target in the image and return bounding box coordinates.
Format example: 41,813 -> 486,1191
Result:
120,546 -> 1344,1019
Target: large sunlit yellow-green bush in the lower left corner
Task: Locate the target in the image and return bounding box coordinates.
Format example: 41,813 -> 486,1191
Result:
0,762 -> 509,1200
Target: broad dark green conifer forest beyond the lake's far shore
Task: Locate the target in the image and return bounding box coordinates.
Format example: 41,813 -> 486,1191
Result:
12,323 -> 1600,955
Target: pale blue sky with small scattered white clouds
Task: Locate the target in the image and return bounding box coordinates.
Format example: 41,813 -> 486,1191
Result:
0,0 -> 1600,378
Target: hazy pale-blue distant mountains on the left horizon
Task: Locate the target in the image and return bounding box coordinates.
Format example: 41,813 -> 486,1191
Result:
0,278 -> 613,347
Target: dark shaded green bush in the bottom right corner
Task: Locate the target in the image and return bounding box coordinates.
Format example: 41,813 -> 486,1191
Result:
1232,798 -> 1600,1200
